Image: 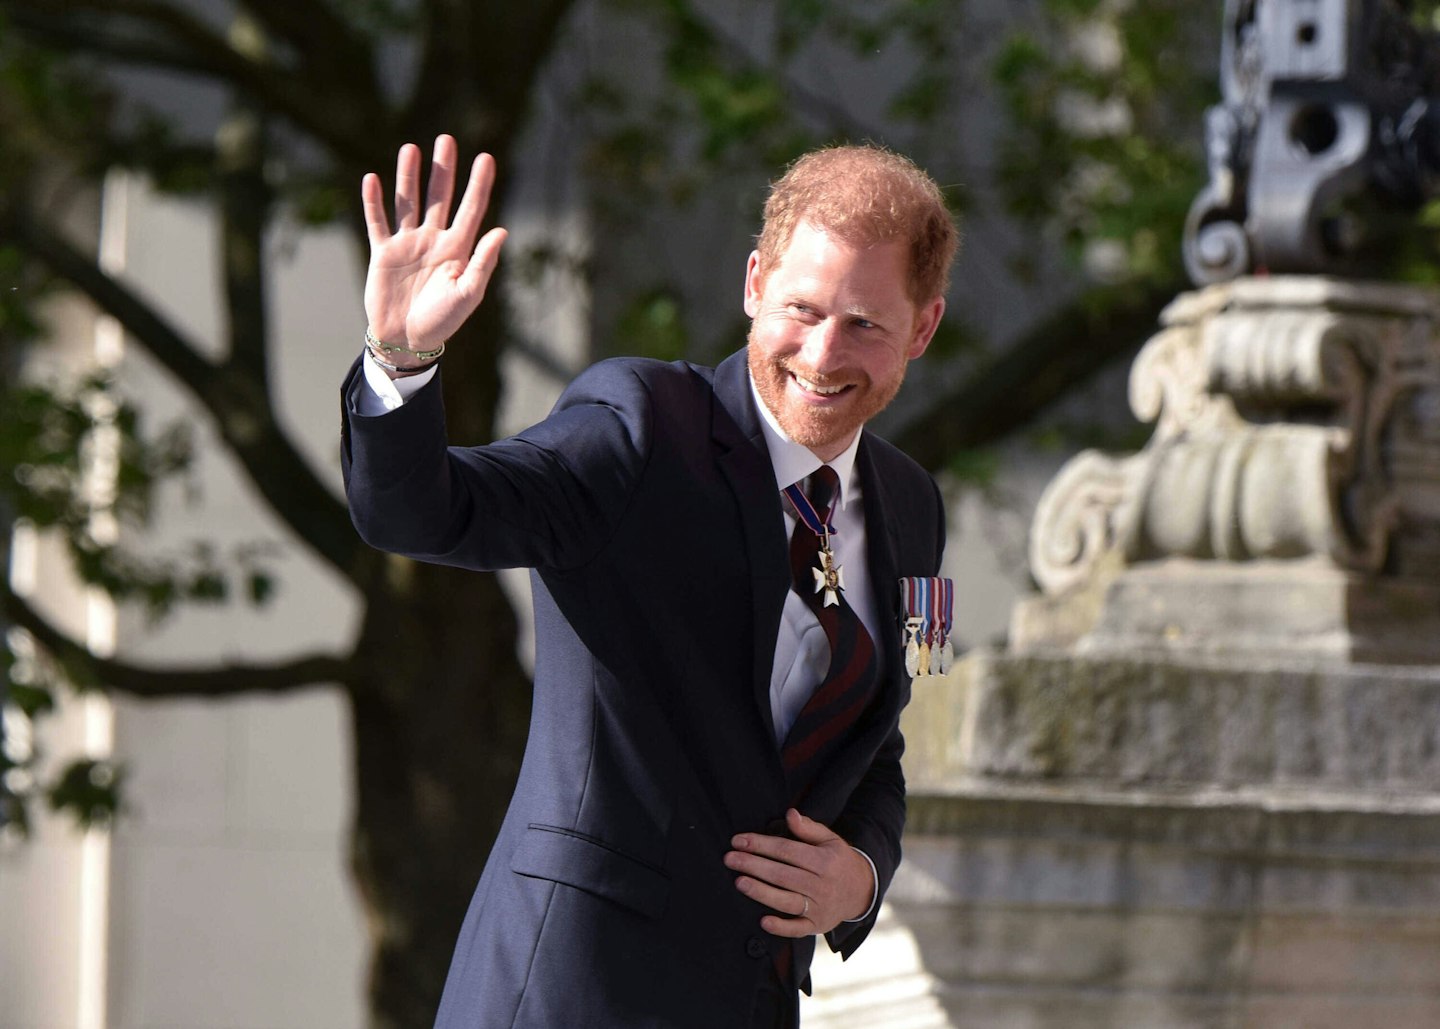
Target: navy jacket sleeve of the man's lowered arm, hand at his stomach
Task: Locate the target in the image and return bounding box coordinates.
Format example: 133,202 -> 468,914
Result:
825,476 -> 946,958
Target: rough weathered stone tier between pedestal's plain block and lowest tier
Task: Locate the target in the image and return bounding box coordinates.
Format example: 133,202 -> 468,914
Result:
903,651 -> 1440,796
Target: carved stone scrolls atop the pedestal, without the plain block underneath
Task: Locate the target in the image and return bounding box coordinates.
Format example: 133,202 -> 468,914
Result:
1030,276 -> 1440,659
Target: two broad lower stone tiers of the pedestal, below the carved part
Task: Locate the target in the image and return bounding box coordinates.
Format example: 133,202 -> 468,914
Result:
805,652 -> 1440,1029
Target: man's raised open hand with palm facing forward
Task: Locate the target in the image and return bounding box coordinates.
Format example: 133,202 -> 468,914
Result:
360,135 -> 505,358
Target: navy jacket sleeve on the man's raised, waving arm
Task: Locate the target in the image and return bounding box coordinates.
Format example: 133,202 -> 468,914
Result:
341,361 -> 652,570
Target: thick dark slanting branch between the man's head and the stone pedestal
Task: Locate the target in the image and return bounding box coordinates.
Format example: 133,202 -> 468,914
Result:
894,275 -> 1182,472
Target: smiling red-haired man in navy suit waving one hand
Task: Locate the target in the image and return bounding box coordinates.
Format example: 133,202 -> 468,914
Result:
343,137 -> 956,1029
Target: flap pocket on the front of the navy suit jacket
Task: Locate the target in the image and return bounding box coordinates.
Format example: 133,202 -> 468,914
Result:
510,825 -> 670,918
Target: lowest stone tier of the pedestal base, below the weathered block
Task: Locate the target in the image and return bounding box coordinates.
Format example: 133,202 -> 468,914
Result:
805,780 -> 1440,1029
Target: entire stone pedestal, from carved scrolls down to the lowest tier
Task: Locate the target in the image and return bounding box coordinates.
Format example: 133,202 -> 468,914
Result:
806,278 -> 1440,1029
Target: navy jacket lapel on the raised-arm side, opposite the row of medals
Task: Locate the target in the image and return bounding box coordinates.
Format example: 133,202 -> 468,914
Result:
711,350 -> 791,748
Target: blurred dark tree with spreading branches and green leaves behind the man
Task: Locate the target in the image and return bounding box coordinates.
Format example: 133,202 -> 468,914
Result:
0,0 -> 1220,1026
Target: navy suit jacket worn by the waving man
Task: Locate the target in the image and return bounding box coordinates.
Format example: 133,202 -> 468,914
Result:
343,351 -> 945,1029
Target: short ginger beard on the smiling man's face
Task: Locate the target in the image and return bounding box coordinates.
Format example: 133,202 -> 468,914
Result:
747,327 -> 904,459
